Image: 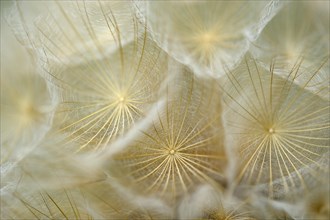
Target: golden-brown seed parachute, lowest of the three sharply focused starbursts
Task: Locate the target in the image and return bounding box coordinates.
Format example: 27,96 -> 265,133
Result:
113,72 -> 226,203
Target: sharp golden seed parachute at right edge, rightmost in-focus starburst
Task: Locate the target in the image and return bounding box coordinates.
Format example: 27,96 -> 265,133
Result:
223,56 -> 330,197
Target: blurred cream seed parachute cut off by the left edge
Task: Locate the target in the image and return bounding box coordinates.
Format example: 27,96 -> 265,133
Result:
1,72 -> 55,162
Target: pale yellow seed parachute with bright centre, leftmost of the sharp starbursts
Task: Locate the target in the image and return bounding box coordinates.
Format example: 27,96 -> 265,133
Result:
38,2 -> 167,151
